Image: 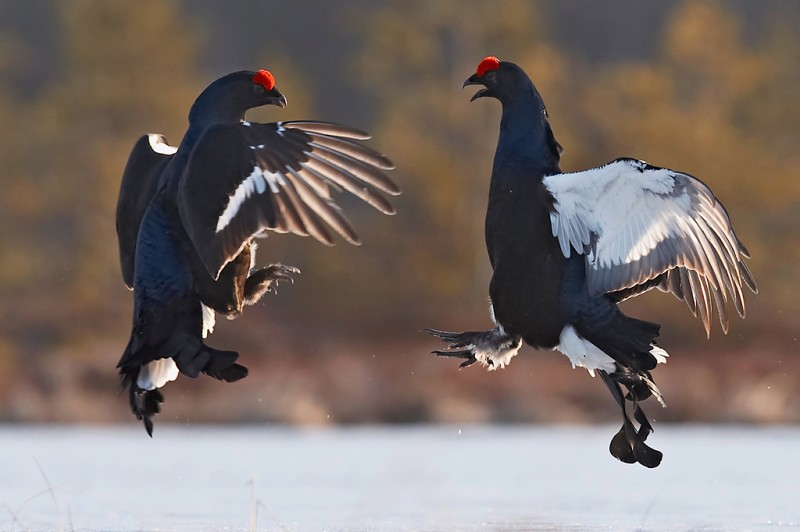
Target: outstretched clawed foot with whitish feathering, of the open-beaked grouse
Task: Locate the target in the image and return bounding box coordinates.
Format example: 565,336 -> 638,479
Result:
425,326 -> 522,370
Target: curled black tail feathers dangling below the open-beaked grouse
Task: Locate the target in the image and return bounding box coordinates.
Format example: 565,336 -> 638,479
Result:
600,370 -> 663,467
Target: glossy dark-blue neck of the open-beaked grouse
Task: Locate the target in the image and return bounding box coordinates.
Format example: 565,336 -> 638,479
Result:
493,94 -> 561,179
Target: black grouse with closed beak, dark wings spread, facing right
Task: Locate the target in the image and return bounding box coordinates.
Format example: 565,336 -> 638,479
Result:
117,70 -> 400,436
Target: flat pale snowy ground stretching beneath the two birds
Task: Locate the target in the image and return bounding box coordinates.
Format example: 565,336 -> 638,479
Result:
0,422 -> 800,531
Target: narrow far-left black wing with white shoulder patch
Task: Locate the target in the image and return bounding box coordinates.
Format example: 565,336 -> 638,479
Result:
117,133 -> 177,289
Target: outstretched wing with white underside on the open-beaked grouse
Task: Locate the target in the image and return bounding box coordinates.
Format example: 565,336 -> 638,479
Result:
544,159 -> 757,334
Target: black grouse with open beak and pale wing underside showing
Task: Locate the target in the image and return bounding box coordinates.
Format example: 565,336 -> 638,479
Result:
428,57 -> 756,467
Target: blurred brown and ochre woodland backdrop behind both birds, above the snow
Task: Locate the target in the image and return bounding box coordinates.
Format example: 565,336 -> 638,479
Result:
0,0 -> 800,425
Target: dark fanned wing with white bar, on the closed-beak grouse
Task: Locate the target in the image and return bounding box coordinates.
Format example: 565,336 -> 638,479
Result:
178,121 -> 400,278
